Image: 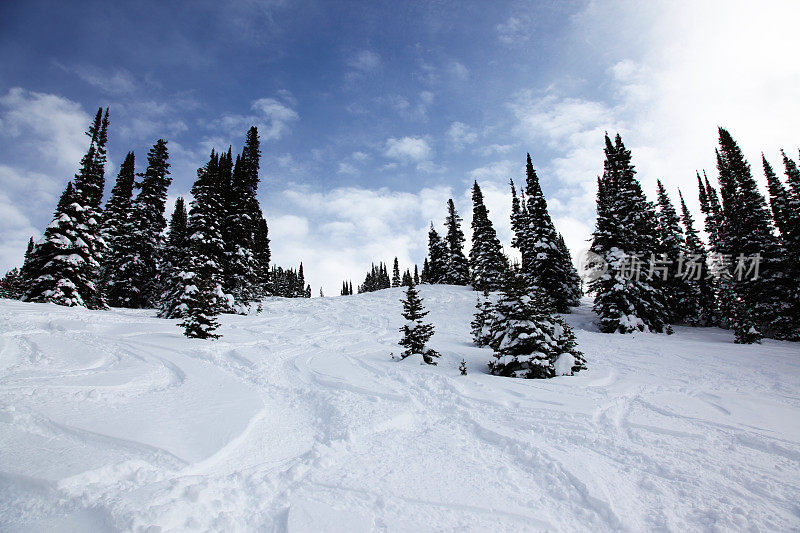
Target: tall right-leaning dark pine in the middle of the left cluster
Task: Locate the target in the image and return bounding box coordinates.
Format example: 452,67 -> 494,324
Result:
108,139 -> 172,309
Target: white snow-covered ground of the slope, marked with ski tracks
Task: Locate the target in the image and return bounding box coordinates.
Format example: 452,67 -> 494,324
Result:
0,286 -> 800,532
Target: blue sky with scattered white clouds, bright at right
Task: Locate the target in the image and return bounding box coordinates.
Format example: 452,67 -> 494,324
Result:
0,0 -> 800,295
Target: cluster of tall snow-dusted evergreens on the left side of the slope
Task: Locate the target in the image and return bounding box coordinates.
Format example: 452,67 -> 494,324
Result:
0,108 -> 311,338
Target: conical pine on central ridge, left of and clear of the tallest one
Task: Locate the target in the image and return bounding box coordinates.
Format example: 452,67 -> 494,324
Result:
469,181 -> 508,291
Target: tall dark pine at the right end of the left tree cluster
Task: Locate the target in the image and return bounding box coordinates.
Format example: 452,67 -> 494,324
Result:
225,126 -> 268,312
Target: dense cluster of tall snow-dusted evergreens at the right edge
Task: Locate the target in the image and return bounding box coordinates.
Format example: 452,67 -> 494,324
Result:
589,128 -> 800,343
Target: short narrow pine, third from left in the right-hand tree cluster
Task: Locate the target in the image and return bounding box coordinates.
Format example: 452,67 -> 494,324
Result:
678,191 -> 717,326
